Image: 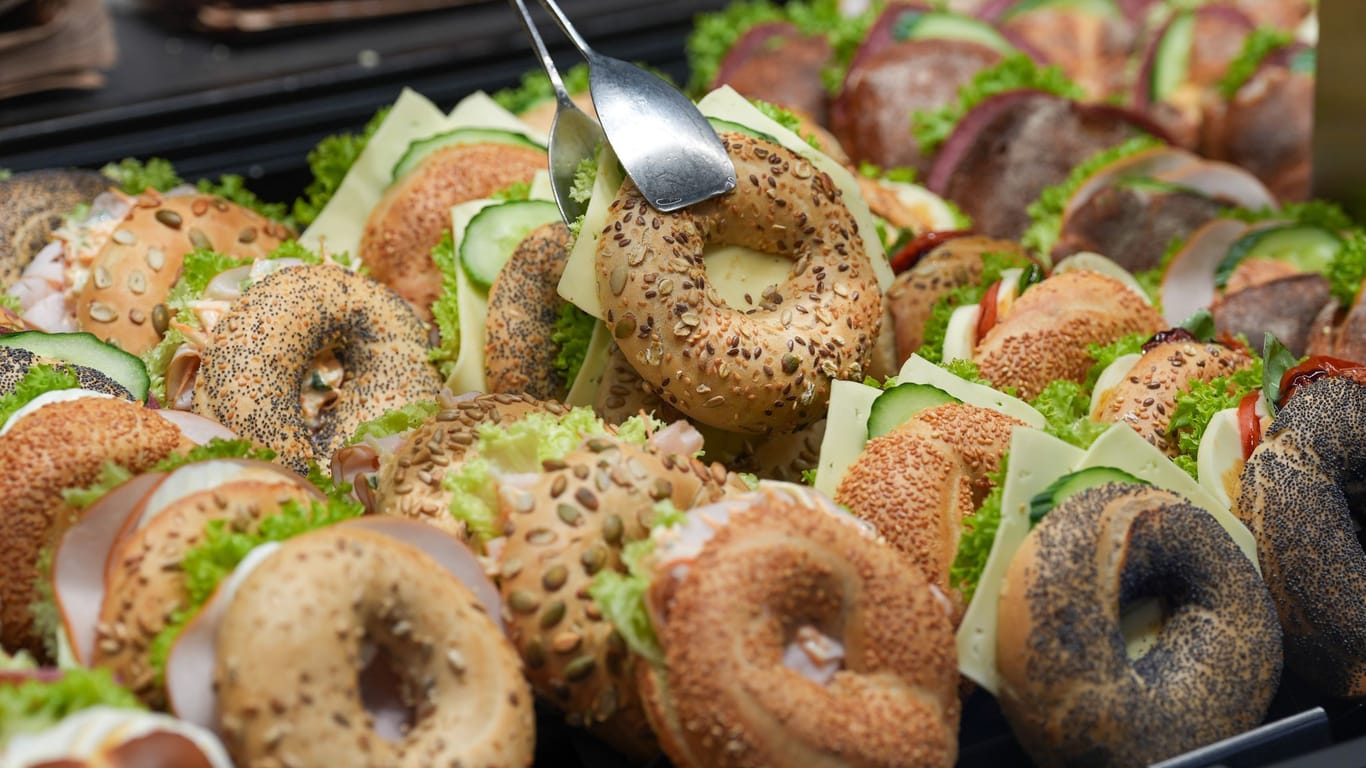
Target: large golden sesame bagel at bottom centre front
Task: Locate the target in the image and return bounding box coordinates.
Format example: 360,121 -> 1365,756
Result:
639,489 -> 960,768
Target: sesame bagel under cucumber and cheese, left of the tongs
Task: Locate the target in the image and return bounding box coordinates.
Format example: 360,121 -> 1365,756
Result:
359,143 -> 546,320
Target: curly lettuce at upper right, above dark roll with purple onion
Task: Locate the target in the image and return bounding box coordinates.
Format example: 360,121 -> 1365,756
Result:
911,53 -> 1086,154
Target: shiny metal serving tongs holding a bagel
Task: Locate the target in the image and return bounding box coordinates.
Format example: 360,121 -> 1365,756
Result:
510,0 -> 735,221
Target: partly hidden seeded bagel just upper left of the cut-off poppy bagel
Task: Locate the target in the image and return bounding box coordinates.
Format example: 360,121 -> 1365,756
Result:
1093,336 -> 1253,456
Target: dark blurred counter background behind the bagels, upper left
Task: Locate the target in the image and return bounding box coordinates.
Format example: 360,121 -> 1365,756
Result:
0,0 -> 725,200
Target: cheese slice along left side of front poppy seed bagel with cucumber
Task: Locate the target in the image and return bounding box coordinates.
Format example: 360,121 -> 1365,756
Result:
958,426 -> 1085,694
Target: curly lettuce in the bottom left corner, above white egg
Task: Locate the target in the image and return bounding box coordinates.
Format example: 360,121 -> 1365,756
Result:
0,668 -> 143,752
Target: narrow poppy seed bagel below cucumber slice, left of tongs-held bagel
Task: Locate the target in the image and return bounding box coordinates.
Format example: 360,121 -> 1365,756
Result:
484,221 -> 572,399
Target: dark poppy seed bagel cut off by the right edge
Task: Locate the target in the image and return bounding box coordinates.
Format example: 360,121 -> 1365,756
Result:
1236,373 -> 1366,696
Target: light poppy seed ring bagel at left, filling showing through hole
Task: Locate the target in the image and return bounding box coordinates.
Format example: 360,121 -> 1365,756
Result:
194,265 -> 441,473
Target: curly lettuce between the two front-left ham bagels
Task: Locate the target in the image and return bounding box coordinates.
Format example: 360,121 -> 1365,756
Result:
148,497 -> 365,681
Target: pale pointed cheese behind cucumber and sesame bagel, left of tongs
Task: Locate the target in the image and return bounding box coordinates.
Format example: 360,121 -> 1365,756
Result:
299,89 -> 544,256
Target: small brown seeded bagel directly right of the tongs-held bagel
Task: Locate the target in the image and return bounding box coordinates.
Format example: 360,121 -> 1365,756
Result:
887,235 -> 1025,361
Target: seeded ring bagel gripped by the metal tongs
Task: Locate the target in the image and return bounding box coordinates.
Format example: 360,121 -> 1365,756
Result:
596,133 -> 882,433
